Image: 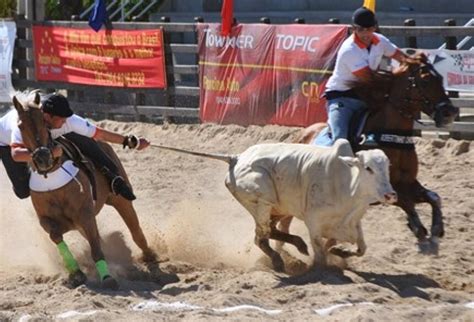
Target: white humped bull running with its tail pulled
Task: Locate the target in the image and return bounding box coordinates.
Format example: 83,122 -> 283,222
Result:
155,139 -> 397,271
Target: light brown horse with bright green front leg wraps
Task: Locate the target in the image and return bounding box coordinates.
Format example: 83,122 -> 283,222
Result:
13,92 -> 155,289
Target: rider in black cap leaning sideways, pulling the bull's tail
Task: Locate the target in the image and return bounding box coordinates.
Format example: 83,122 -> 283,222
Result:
11,94 -> 150,200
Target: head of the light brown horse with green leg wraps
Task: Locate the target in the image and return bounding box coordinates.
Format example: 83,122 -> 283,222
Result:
13,91 -> 54,173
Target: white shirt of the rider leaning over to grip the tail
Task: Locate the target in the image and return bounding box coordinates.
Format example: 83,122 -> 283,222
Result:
11,114 -> 97,146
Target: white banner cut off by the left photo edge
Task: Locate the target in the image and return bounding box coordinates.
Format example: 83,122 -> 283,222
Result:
0,20 -> 16,103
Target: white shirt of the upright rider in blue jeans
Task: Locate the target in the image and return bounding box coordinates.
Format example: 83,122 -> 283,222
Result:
326,33 -> 398,91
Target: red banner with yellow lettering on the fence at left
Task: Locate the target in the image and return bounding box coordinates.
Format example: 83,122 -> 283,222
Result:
33,26 -> 166,88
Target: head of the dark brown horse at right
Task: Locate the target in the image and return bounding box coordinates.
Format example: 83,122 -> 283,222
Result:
394,53 -> 459,127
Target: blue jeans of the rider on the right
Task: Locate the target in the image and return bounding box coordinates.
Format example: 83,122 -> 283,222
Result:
313,97 -> 366,146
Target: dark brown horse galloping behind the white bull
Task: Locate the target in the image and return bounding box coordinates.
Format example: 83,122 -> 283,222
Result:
292,53 -> 459,251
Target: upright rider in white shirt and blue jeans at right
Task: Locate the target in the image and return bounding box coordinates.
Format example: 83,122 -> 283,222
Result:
315,7 -> 406,146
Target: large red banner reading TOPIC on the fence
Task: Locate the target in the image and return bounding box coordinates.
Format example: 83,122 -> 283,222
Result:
198,24 -> 348,126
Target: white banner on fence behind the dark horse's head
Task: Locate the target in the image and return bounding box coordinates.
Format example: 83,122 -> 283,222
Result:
404,49 -> 474,92
